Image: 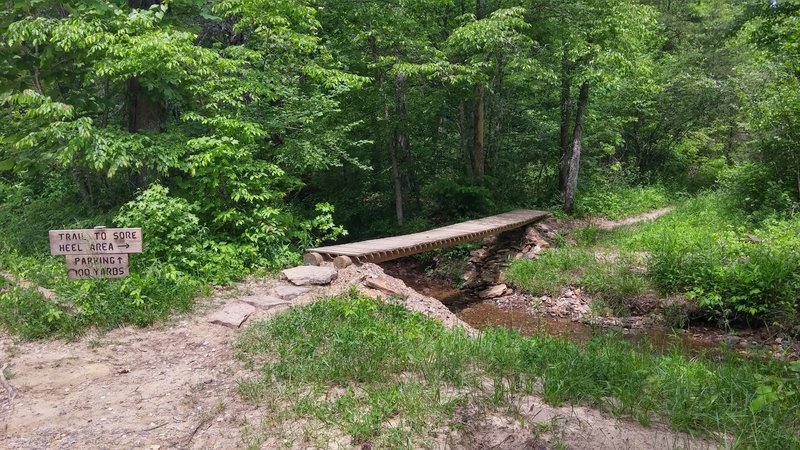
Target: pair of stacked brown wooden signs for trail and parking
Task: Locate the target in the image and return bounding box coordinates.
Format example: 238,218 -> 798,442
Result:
49,227 -> 142,280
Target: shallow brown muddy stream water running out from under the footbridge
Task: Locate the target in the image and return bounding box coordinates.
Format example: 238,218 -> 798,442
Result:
382,259 -> 720,354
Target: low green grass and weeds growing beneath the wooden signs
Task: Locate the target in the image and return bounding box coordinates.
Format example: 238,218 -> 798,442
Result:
0,250 -> 205,339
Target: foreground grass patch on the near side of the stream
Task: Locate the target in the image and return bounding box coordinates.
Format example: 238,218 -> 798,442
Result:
237,294 -> 800,449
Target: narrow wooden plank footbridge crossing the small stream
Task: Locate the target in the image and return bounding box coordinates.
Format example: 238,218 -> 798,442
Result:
304,210 -> 550,268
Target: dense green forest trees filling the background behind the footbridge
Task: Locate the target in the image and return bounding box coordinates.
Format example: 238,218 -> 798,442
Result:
0,0 -> 800,330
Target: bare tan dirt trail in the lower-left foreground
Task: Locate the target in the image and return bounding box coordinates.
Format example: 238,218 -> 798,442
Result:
0,288 -> 260,449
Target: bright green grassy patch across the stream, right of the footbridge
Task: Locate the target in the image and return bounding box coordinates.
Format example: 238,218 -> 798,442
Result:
508,193 -> 800,329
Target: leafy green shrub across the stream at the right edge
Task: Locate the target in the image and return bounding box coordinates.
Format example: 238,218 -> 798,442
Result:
648,195 -> 800,320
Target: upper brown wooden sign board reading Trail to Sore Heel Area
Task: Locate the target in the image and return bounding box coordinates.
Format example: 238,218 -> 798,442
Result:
50,228 -> 142,255
